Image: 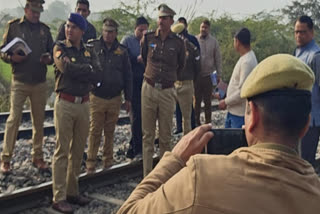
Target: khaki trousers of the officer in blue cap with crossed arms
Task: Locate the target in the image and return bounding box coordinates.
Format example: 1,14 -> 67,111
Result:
52,97 -> 89,202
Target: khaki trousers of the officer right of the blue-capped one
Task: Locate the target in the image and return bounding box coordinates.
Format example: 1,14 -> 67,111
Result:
86,94 -> 122,168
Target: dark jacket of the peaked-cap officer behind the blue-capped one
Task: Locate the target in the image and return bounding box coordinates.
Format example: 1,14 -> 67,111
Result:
88,37 -> 132,101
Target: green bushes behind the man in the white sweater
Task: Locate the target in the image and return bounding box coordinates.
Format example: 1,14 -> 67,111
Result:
189,12 -> 295,82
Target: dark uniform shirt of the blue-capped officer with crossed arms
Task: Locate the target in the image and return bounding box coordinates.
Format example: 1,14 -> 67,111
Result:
53,40 -> 102,96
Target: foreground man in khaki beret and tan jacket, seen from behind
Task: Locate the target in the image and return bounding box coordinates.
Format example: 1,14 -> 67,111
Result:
118,54 -> 320,214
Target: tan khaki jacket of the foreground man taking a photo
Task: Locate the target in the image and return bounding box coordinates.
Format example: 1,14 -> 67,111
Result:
118,142 -> 320,214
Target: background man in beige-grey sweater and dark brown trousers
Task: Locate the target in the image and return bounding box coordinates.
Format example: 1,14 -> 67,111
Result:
194,19 -> 222,126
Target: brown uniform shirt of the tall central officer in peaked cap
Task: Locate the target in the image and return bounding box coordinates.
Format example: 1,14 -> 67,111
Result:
141,29 -> 186,84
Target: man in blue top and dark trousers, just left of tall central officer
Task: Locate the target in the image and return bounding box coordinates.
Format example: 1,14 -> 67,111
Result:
121,16 -> 149,158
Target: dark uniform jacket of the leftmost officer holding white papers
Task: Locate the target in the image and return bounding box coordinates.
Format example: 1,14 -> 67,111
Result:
1,17 -> 53,84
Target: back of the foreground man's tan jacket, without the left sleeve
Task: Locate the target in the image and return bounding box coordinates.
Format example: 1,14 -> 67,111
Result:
188,144 -> 320,214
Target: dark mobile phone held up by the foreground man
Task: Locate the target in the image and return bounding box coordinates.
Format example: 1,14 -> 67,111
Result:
205,129 -> 248,155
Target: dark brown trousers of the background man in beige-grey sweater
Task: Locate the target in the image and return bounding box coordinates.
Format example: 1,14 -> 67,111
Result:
194,75 -> 213,126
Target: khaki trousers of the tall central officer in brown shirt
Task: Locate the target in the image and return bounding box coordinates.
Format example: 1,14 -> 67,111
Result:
141,81 -> 177,176
